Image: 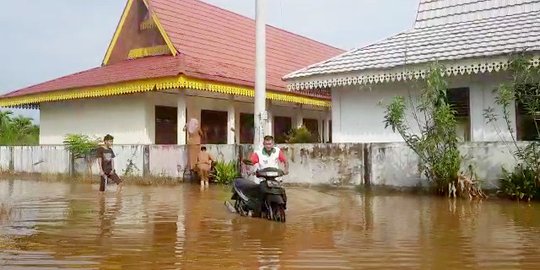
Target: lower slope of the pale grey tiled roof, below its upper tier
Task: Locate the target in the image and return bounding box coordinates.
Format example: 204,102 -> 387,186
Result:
285,4 -> 540,81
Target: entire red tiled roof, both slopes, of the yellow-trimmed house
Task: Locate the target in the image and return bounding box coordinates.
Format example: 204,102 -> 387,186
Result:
2,0 -> 343,97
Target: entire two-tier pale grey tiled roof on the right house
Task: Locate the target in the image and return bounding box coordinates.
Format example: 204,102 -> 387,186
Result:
285,0 -> 540,80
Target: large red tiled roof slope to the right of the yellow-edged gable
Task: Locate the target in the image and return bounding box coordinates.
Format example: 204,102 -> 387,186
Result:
148,0 -> 344,90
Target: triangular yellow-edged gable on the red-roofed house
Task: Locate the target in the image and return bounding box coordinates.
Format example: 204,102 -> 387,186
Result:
103,0 -> 176,65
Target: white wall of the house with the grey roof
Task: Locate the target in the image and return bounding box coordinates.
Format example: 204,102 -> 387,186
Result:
332,71 -> 516,143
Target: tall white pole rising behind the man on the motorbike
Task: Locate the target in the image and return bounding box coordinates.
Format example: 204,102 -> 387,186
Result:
253,0 -> 267,149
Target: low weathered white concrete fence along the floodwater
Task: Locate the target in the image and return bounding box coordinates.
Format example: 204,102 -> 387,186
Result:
0,142 -> 516,189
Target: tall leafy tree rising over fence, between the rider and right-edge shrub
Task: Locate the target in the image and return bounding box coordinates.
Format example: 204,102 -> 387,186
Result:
384,64 -> 485,198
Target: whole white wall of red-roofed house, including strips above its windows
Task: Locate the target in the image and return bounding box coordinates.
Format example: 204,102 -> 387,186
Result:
39,91 -> 328,144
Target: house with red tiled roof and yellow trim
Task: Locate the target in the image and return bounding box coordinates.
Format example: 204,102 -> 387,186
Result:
0,0 -> 343,144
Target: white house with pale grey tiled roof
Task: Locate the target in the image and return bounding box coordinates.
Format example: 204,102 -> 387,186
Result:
284,0 -> 540,143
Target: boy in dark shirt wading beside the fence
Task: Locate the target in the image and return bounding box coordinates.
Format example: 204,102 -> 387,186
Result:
97,134 -> 122,192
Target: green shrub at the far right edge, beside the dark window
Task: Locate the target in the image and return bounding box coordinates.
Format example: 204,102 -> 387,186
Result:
484,53 -> 540,200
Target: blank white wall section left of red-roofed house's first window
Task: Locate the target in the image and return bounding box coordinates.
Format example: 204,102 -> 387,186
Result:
39,95 -> 150,144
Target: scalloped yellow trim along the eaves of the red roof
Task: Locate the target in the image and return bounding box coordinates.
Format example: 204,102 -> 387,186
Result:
0,75 -> 331,107
